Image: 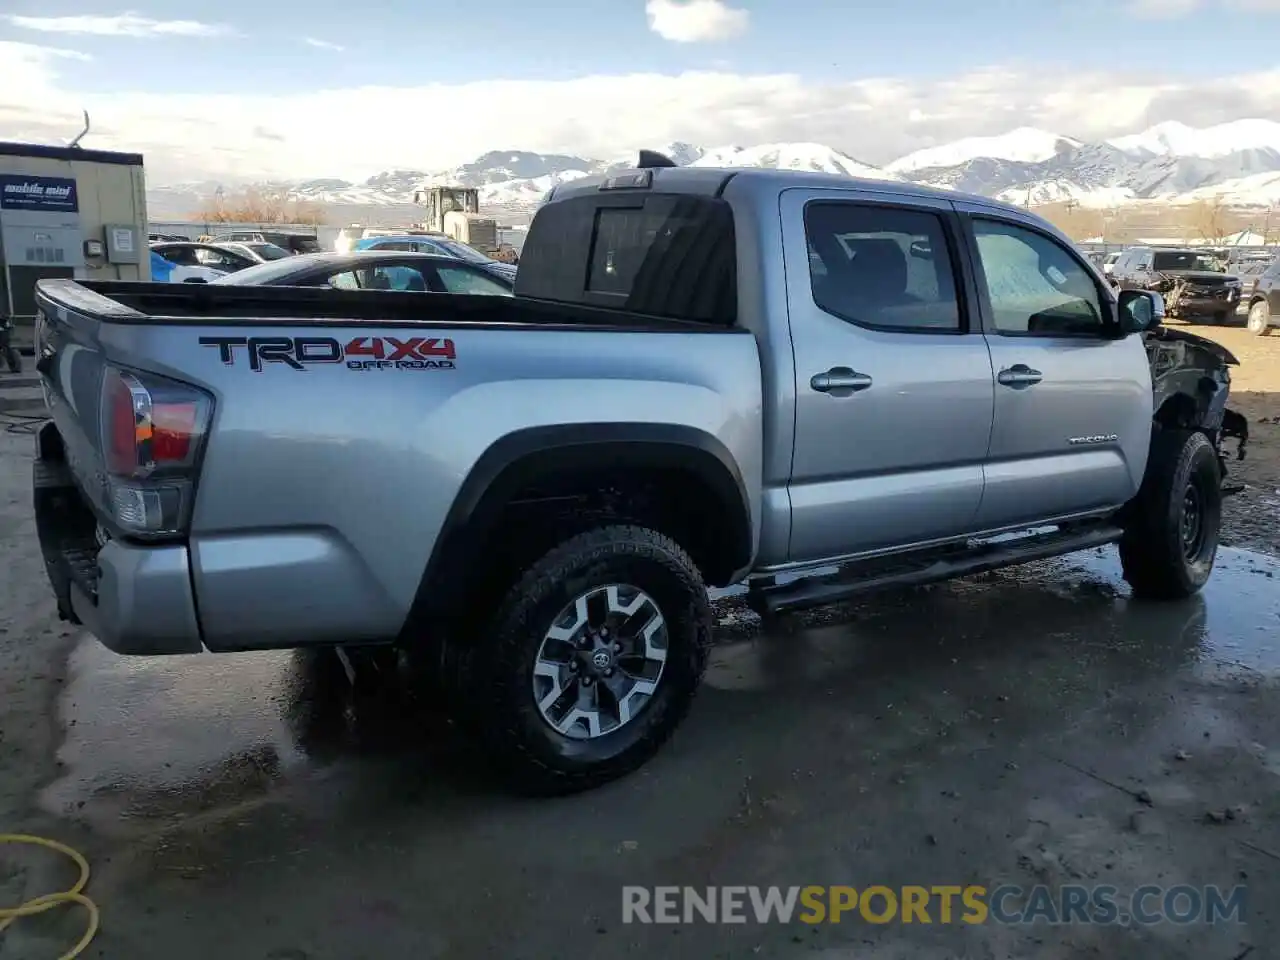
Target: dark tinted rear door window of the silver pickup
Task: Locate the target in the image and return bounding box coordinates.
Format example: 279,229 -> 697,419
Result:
804,202 -> 961,333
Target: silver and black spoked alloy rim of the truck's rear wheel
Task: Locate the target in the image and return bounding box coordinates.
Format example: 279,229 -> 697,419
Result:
534,584 -> 667,740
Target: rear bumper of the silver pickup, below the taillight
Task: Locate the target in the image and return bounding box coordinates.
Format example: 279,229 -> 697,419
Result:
32,422 -> 204,654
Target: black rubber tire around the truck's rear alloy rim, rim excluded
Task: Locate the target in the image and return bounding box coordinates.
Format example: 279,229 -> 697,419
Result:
458,525 -> 712,795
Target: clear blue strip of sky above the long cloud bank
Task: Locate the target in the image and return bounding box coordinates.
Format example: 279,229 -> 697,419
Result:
0,0 -> 1259,92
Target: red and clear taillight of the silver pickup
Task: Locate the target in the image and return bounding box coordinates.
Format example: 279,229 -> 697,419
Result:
101,367 -> 212,536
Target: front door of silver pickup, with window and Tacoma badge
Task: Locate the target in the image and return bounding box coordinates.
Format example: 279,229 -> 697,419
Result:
961,205 -> 1152,529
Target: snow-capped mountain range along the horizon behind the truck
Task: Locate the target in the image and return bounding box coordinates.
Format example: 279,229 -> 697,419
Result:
148,119 -> 1280,221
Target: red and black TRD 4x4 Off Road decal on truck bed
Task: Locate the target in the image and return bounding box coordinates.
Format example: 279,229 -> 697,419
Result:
200,337 -> 457,372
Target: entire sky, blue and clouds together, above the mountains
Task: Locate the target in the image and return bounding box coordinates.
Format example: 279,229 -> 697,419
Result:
0,0 -> 1280,175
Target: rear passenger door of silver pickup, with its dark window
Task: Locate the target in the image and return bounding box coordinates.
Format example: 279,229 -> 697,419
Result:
781,189 -> 993,562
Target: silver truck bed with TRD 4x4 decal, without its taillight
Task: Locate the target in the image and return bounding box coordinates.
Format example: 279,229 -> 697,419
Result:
37,273 -> 763,653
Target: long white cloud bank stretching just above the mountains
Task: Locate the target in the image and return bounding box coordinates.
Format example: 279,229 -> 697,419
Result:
0,42 -> 1280,183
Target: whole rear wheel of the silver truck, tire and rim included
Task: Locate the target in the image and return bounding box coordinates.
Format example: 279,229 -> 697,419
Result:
461,525 -> 712,794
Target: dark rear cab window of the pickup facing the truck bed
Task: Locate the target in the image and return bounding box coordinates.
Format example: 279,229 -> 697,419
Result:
516,192 -> 737,326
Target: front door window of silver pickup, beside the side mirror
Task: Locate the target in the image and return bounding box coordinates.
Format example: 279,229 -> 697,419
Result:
973,219 -> 1103,337
